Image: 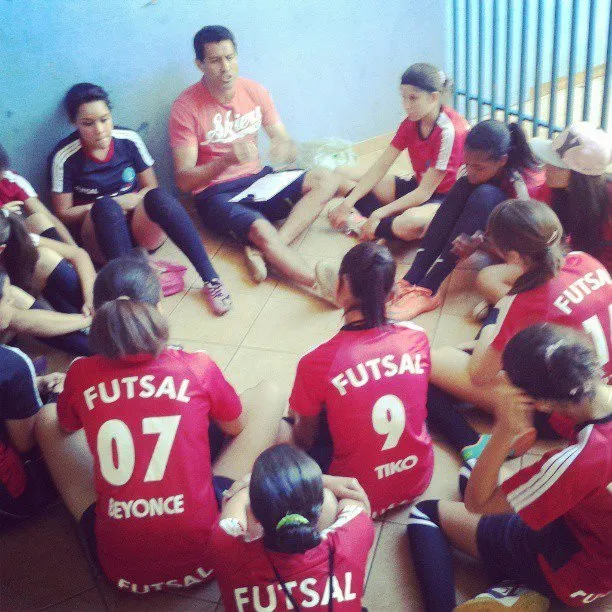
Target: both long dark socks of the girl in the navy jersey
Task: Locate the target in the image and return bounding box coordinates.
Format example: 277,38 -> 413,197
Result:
91,187 -> 219,282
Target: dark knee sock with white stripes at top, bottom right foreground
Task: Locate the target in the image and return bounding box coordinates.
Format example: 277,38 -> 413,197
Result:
406,499 -> 456,612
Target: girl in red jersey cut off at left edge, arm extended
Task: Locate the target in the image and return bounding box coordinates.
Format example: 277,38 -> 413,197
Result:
0,144 -> 75,244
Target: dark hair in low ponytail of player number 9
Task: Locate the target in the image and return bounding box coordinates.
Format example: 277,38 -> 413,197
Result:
339,242 -> 395,328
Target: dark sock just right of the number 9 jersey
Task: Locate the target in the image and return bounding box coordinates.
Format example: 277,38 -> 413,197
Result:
427,383 -> 480,452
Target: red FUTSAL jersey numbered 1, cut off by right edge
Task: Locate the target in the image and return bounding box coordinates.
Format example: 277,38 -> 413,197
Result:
491,251 -> 612,438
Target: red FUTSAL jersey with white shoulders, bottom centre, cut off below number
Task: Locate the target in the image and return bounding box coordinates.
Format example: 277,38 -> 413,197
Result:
212,506 -> 374,612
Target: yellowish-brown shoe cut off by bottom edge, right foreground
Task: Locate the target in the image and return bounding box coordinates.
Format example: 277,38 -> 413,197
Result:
455,581 -> 550,612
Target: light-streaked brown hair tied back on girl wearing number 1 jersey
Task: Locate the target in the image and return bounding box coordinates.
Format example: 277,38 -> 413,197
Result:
487,200 -> 563,295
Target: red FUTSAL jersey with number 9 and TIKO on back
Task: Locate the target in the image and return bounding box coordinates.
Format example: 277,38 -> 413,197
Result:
289,323 -> 433,516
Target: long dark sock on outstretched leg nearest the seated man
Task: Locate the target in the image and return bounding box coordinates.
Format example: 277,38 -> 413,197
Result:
144,188 -> 219,282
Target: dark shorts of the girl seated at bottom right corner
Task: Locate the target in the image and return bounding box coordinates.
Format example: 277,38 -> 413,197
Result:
476,514 -> 558,603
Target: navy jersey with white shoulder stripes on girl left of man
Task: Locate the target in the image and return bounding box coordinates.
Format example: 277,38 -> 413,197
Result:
49,128 -> 153,203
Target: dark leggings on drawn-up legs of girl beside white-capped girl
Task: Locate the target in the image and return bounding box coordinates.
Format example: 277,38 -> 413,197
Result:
404,177 -> 508,293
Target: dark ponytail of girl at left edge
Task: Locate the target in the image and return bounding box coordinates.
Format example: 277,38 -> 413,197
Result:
0,208 -> 39,295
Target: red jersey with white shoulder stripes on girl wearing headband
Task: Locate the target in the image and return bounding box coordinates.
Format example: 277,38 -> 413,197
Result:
391,106 -> 470,193
